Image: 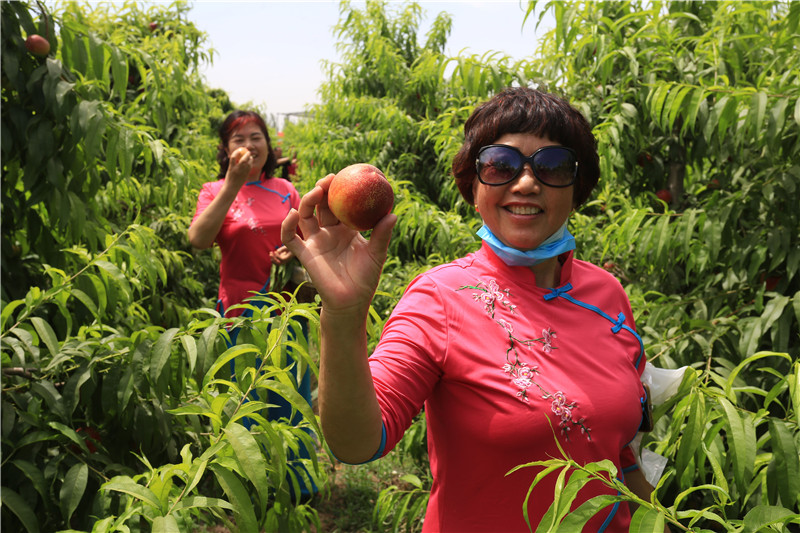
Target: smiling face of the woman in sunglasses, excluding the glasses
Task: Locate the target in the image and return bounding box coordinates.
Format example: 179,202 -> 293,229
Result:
472,133 -> 575,251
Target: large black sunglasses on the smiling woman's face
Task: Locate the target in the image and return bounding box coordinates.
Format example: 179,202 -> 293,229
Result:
475,144 -> 578,187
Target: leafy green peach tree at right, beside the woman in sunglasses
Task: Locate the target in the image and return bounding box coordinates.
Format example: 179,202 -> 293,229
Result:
530,2 -> 800,530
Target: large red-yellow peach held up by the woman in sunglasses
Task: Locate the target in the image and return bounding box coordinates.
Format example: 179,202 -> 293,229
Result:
328,163 -> 394,231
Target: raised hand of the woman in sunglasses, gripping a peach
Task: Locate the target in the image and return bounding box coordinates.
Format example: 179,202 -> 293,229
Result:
281,174 -> 397,313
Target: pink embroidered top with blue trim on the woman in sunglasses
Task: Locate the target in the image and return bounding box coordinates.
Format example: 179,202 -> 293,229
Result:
370,245 -> 645,533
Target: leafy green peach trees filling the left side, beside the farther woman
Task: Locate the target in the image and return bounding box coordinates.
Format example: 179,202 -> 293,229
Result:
0,2 -> 323,531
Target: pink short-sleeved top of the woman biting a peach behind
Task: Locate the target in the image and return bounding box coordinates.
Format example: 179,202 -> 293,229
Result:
192,178 -> 300,316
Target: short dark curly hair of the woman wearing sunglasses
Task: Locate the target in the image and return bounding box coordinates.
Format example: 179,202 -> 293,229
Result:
453,87 -> 600,207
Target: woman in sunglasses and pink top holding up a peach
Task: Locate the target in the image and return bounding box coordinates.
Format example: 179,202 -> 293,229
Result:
282,88 -> 664,533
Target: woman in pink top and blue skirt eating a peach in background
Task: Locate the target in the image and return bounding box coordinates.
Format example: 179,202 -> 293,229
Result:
189,111 -> 317,497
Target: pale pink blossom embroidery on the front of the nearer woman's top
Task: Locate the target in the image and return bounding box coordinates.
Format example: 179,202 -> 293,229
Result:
456,279 -> 592,440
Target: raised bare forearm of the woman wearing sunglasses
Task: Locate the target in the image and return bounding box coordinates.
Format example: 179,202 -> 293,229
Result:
319,306 -> 381,463
